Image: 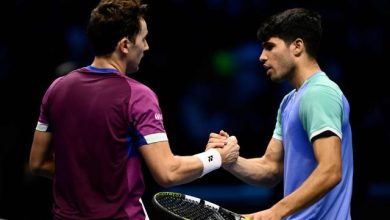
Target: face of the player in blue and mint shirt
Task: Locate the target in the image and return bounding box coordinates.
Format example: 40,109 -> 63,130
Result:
259,37 -> 295,82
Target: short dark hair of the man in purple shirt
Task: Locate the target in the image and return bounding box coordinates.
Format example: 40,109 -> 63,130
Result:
87,0 -> 147,56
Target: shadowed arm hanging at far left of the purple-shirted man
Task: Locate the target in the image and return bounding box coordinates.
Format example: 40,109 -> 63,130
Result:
29,130 -> 55,178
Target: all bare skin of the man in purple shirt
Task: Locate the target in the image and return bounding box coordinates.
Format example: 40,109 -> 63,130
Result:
29,19 -> 239,187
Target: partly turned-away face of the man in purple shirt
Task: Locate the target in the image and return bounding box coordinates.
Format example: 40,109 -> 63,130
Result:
126,19 -> 149,73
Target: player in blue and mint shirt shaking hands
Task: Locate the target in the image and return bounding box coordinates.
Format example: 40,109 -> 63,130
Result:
209,8 -> 353,220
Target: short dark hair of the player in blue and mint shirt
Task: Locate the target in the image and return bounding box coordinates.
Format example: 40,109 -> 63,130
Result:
257,8 -> 322,57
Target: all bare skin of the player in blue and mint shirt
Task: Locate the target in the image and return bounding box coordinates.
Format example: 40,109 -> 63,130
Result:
209,37 -> 342,220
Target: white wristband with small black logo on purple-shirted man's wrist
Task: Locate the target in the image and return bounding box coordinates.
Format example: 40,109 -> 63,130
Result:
194,148 -> 222,177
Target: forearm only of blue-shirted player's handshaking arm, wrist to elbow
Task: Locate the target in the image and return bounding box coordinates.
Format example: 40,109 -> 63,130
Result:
224,157 -> 283,187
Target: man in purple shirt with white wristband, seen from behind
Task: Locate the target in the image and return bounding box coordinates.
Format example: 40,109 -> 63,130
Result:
30,0 -> 239,220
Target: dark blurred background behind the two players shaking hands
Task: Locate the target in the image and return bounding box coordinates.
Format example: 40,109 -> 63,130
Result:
0,0 -> 390,220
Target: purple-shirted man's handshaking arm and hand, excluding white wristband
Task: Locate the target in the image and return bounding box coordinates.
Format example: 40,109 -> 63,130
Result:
140,138 -> 239,187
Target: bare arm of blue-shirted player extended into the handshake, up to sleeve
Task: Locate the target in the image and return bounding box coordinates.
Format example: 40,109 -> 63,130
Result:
224,138 -> 284,186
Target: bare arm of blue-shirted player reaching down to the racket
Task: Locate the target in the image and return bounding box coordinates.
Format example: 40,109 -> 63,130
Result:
250,136 -> 342,219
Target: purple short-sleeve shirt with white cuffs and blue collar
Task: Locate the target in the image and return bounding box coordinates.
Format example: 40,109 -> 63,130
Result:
36,66 -> 167,220
